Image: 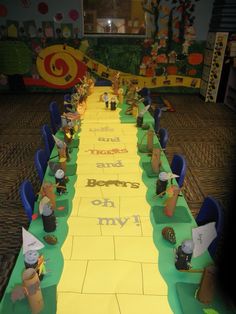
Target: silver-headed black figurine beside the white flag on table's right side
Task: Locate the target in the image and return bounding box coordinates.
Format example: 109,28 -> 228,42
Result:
175,240 -> 194,270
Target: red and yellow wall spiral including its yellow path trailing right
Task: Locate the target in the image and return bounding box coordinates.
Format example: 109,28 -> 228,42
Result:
36,45 -> 200,89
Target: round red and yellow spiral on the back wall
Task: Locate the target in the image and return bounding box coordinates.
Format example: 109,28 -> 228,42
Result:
36,45 -> 87,89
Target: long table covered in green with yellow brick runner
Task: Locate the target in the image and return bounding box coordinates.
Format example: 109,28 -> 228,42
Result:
0,87 -> 212,314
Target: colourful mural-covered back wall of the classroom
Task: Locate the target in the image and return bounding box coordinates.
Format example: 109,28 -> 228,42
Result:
0,0 -> 214,92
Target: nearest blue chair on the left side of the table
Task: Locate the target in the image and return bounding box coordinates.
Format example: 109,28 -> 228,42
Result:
19,180 -> 36,221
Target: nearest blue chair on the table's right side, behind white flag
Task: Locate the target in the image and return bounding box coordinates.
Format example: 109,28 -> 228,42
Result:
196,196 -> 224,259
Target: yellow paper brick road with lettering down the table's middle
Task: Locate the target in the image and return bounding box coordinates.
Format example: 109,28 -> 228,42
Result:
57,87 -> 172,314
